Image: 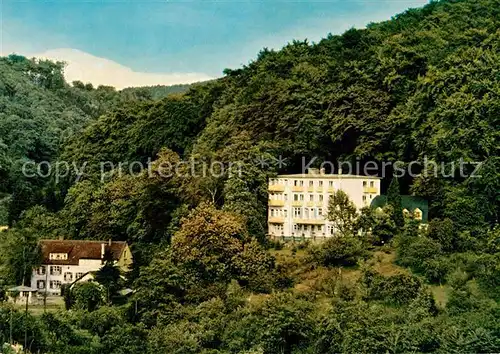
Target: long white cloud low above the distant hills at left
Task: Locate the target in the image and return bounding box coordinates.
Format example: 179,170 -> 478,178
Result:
20,48 -> 213,89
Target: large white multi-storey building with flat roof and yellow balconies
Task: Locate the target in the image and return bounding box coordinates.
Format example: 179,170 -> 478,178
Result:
268,169 -> 380,239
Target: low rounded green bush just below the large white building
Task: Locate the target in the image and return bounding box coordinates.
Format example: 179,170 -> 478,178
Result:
309,236 -> 365,267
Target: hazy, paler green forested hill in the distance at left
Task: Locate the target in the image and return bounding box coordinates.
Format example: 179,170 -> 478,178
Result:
0,55 -> 189,225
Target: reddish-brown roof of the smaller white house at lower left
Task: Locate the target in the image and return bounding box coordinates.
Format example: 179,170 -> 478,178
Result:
40,240 -> 127,265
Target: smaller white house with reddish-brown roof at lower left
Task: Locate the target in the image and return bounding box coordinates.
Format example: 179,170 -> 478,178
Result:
31,240 -> 133,295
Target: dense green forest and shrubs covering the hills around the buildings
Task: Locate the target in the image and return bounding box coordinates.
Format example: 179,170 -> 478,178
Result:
0,0 -> 500,353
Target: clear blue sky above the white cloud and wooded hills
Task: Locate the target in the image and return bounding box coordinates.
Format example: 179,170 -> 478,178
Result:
0,0 -> 427,76
